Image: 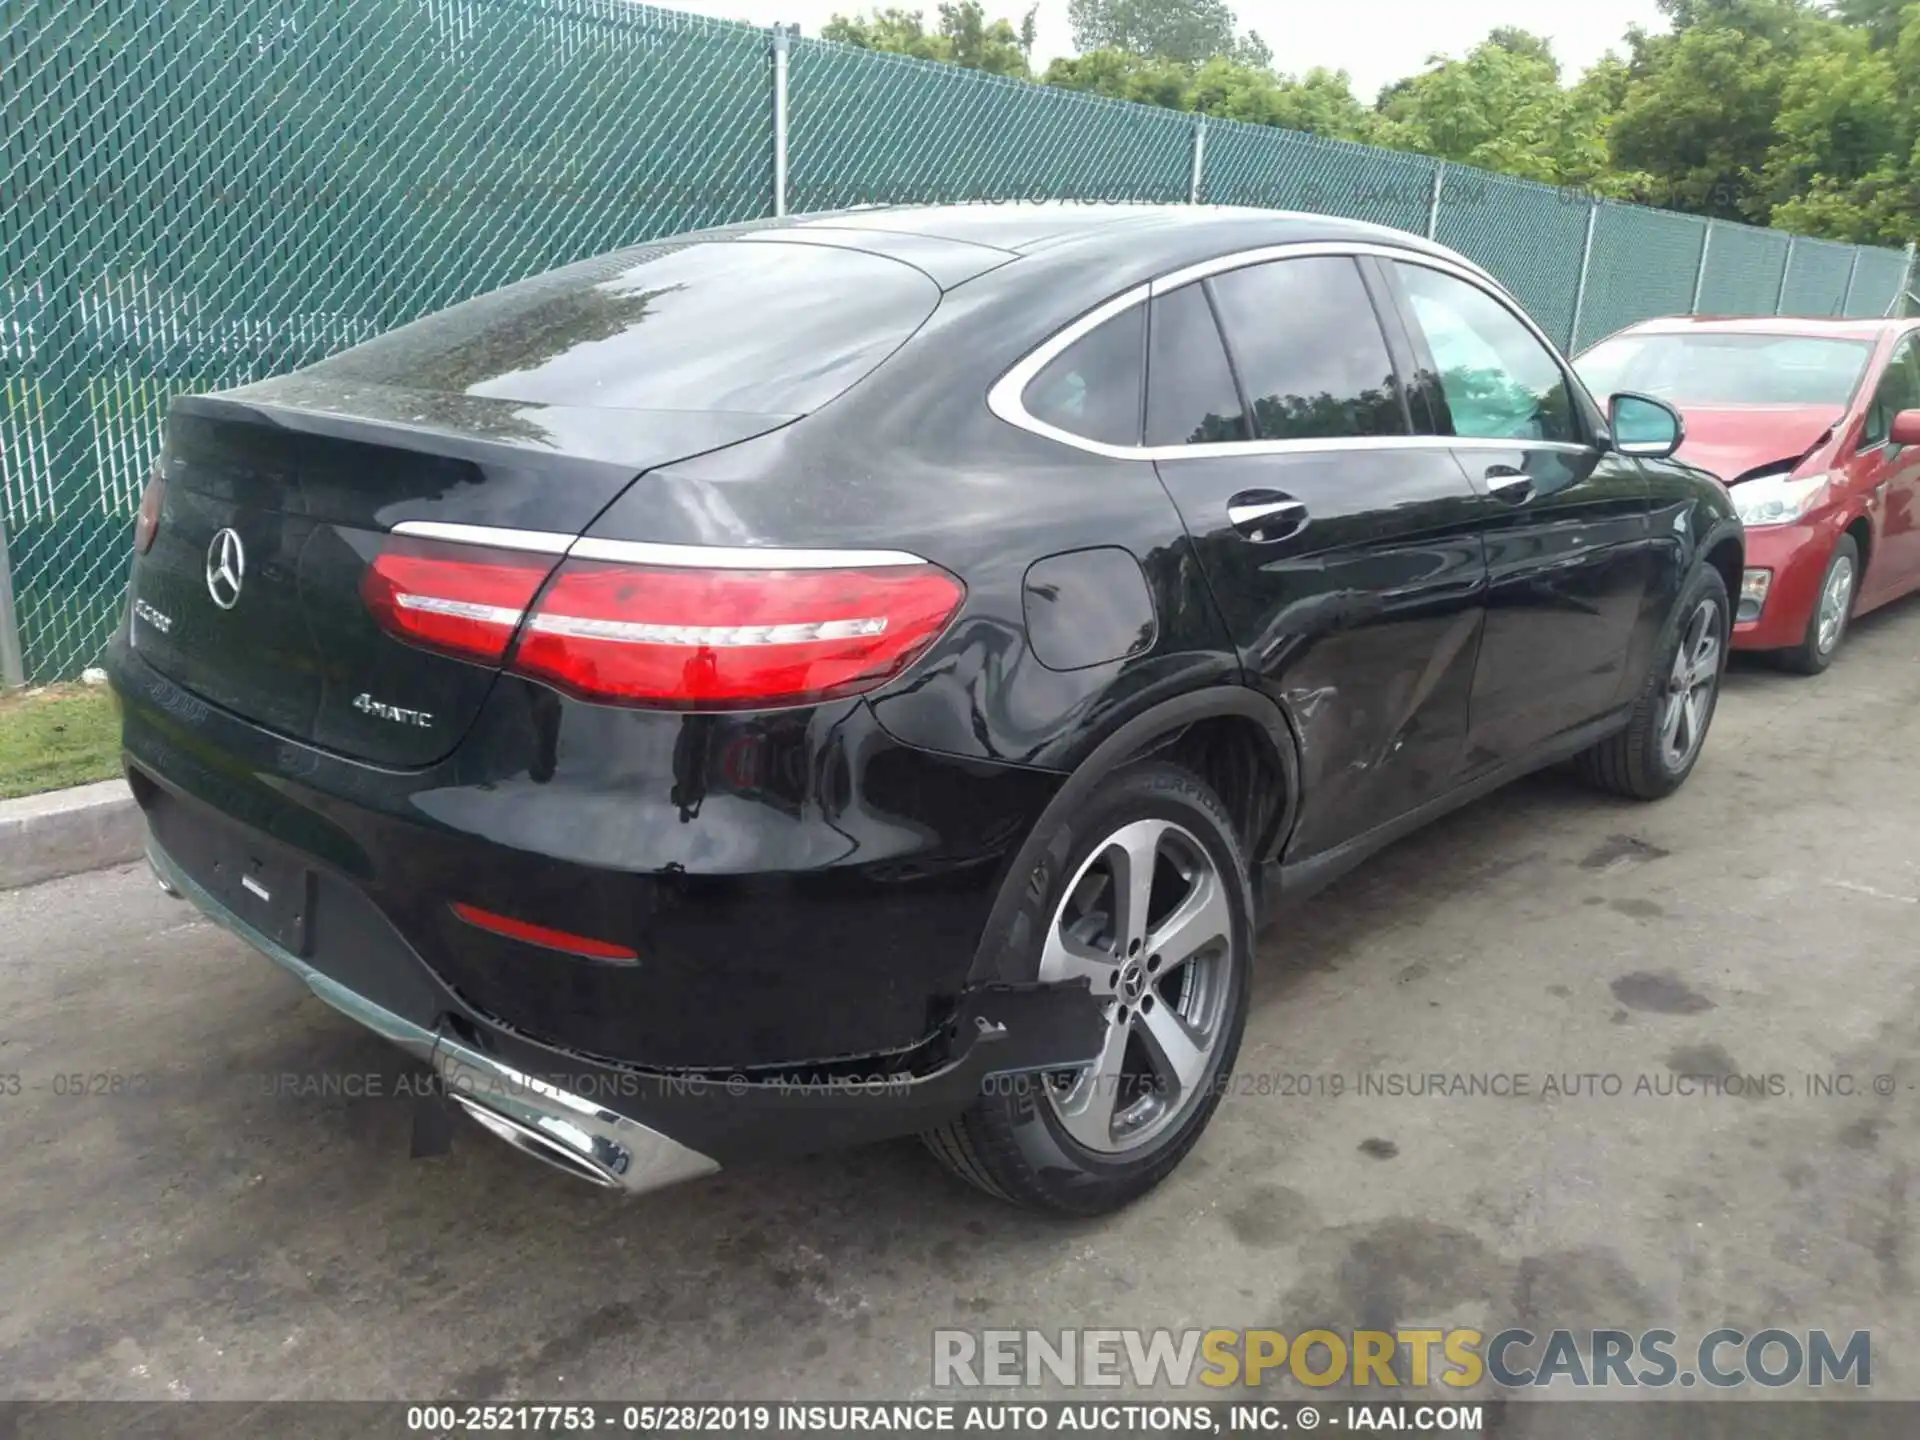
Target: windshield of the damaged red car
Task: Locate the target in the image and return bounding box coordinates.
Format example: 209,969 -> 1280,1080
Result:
1572,332 -> 1872,407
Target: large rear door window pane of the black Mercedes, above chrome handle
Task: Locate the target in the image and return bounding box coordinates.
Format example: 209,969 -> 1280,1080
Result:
1210,255 -> 1409,440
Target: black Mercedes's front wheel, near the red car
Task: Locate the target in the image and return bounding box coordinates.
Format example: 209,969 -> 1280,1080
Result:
1576,564 -> 1732,801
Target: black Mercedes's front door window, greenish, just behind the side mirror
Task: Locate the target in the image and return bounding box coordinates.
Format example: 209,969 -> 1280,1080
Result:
1394,261 -> 1582,444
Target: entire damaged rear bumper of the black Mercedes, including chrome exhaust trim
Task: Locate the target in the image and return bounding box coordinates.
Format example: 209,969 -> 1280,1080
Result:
108,639 -> 1102,1190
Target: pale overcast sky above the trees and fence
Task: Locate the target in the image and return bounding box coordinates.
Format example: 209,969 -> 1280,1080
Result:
660,0 -> 1665,102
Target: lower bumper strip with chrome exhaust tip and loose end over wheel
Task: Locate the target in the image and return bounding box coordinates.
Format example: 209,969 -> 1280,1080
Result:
148,843 -> 1102,1194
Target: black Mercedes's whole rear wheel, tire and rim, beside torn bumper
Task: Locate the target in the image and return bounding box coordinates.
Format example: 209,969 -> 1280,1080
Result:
924,762 -> 1254,1215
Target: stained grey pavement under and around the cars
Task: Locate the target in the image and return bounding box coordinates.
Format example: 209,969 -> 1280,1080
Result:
0,601 -> 1920,1400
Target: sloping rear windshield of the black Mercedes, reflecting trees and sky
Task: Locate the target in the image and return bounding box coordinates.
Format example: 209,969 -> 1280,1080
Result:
293,242 -> 939,415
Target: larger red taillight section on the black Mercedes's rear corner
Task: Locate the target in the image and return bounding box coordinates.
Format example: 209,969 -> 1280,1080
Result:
513,561 -> 964,710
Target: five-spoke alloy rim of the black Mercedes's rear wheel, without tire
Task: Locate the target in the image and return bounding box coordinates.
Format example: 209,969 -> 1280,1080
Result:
1041,820 -> 1233,1154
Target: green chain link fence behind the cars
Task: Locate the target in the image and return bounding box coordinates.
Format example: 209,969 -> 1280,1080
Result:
0,0 -> 1910,684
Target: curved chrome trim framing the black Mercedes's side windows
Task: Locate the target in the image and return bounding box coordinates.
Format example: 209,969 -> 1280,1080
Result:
987,240 -> 1596,461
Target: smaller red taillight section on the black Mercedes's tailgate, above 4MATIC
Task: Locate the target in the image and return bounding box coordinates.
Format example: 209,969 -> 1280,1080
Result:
361,536 -> 553,664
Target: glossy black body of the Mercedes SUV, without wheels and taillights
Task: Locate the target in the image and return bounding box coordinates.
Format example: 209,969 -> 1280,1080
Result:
108,205 -> 1740,1198
